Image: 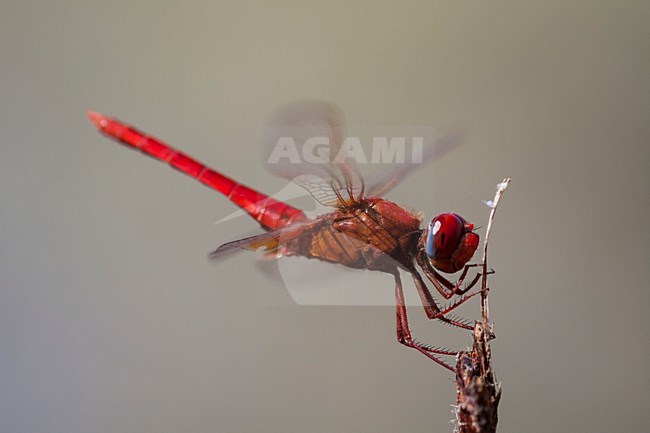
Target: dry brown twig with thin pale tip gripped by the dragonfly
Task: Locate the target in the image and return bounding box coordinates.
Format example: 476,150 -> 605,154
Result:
455,178 -> 510,433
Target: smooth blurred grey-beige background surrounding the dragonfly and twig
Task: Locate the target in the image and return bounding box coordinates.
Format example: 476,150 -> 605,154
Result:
0,0 -> 650,433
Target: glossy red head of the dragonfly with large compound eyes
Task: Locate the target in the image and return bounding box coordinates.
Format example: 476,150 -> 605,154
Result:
423,213 -> 479,273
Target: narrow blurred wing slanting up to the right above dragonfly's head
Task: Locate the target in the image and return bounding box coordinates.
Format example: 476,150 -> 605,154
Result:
366,131 -> 463,197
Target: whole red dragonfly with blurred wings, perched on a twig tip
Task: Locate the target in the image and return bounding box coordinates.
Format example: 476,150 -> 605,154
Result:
88,101 -> 479,371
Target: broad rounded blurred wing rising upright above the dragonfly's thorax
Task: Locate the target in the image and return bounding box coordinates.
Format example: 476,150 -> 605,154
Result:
263,100 -> 363,206
